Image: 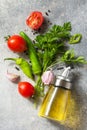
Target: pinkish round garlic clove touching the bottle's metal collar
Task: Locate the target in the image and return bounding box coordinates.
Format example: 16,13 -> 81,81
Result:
41,71 -> 55,85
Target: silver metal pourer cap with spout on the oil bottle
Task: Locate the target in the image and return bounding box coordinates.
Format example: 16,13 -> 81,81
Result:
55,67 -> 72,89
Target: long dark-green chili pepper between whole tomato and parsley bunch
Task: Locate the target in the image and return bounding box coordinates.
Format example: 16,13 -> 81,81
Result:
19,31 -> 42,74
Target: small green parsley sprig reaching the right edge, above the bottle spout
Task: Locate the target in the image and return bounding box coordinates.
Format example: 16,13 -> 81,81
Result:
60,49 -> 87,65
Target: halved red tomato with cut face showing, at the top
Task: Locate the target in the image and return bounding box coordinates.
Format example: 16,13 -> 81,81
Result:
26,11 -> 44,30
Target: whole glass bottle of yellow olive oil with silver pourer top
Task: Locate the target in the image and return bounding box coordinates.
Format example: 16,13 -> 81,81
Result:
39,67 -> 71,123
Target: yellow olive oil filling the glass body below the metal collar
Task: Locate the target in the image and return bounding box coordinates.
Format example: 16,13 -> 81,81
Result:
39,86 -> 71,123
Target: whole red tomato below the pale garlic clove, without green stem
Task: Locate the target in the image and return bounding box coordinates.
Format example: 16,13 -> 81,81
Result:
18,82 -> 35,98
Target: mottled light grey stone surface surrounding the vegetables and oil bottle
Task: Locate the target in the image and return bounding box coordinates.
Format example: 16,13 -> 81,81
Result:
0,0 -> 87,130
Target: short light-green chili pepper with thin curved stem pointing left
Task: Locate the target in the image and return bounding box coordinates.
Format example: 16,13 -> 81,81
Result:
5,58 -> 33,79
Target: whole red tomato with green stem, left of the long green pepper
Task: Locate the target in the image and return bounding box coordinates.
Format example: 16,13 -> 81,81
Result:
7,35 -> 27,52
